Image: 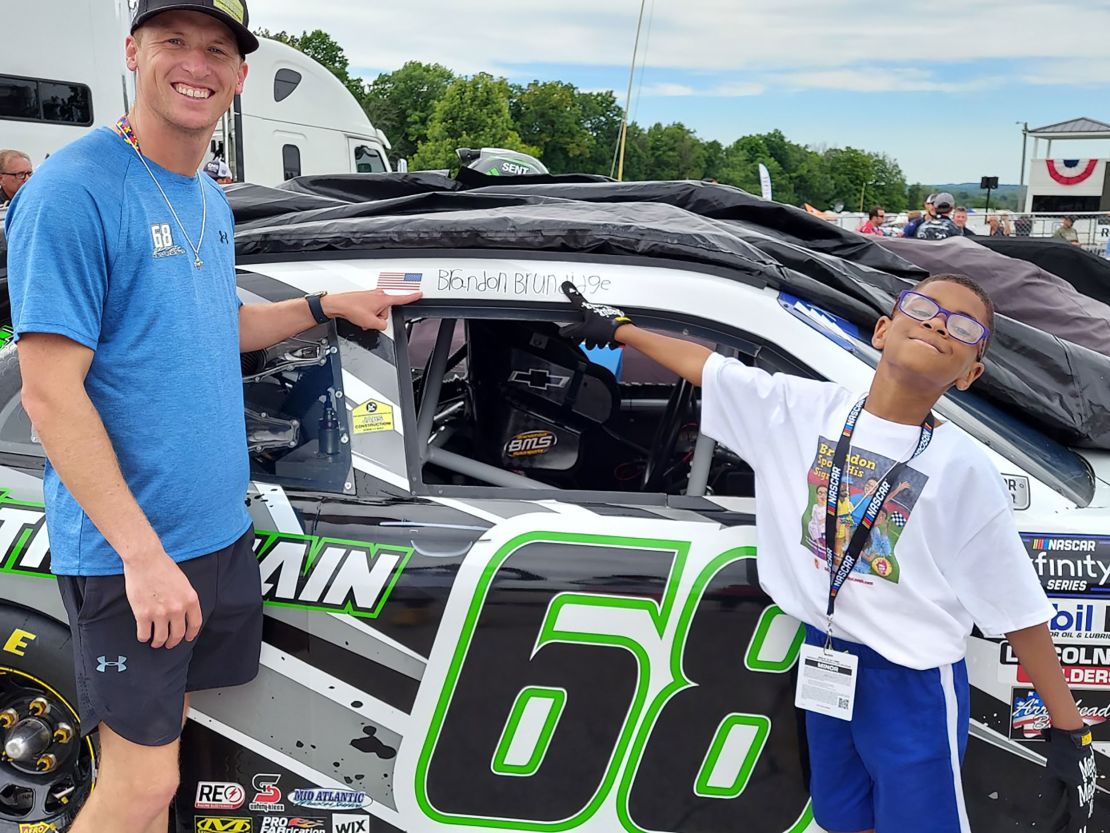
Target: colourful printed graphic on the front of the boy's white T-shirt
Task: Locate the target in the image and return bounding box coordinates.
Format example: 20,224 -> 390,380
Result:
801,436 -> 929,583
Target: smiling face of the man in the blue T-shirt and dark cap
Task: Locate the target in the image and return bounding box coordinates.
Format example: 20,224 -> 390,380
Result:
125,11 -> 246,132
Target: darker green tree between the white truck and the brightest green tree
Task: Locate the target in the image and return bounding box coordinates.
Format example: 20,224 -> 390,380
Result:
363,61 -> 455,159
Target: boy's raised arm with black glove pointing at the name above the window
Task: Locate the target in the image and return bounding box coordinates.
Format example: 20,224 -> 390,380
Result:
559,281 -> 713,385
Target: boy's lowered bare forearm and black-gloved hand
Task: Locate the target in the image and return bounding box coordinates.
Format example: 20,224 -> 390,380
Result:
1006,624 -> 1098,833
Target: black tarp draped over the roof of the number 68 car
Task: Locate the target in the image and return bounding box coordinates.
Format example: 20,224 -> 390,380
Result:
230,173 -> 1110,449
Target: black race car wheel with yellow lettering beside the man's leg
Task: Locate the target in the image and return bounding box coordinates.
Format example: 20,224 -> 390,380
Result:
0,605 -> 97,833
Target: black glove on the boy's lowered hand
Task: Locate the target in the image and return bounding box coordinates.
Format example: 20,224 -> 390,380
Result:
1042,729 -> 1098,833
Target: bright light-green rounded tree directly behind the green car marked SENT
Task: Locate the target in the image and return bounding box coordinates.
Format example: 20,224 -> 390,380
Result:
412,72 -> 539,170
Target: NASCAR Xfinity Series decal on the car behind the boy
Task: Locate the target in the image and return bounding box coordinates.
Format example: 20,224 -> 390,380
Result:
1021,532 -> 1110,599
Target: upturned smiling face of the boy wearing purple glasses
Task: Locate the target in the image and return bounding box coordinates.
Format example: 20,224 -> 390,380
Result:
871,280 -> 989,391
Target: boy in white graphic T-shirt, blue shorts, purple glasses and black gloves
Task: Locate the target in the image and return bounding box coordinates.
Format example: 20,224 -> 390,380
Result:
563,275 -> 1097,833
